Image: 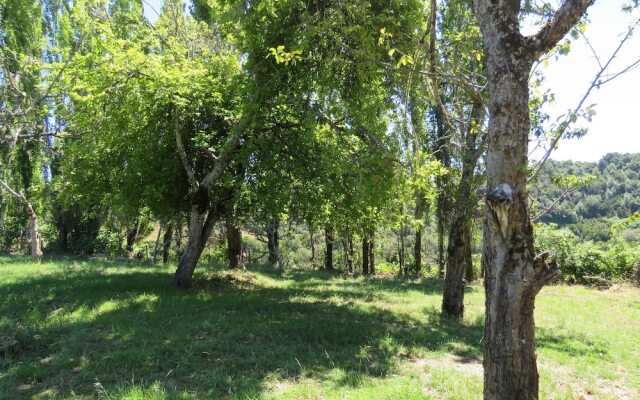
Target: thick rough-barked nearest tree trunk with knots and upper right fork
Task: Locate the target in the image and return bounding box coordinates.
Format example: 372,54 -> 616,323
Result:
474,0 -> 593,400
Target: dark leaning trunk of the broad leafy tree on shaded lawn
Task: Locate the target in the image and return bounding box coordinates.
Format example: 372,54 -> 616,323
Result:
173,188 -> 221,288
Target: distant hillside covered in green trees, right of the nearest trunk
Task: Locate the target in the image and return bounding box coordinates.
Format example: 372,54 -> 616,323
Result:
531,153 -> 640,240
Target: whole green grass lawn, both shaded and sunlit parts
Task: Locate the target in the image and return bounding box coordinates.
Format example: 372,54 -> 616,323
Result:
0,256 -> 640,400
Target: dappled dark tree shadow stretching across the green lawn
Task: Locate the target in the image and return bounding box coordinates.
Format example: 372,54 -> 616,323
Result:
0,260 -> 584,399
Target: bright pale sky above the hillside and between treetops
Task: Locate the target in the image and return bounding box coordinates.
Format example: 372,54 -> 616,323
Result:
143,0 -> 640,161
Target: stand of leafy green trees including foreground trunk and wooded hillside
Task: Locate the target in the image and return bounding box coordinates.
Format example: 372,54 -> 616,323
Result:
0,0 -> 640,399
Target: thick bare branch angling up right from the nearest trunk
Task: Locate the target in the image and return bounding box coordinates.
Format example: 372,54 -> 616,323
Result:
525,0 -> 595,60
